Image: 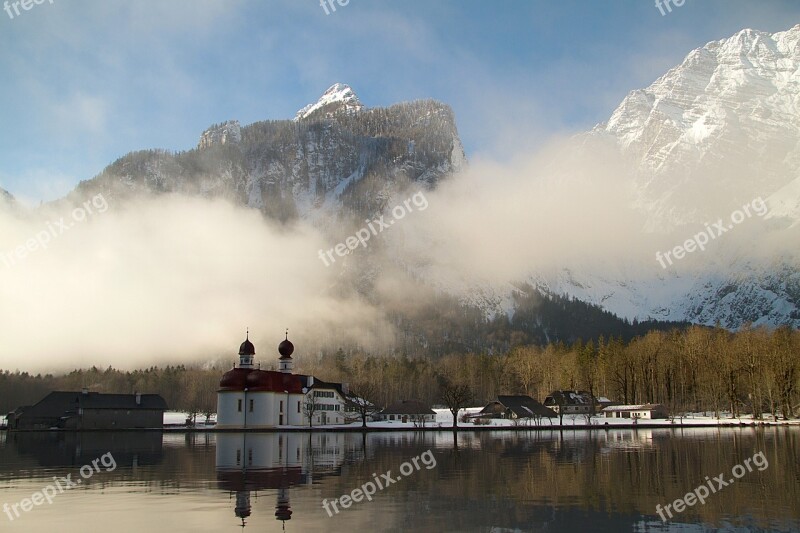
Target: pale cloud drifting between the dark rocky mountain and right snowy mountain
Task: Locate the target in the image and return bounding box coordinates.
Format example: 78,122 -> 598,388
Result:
392,135 -> 646,284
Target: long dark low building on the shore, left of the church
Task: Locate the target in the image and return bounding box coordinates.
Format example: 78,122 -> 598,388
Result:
8,389 -> 167,431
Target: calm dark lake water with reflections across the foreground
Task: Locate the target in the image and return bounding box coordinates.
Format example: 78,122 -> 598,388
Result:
0,428 -> 800,533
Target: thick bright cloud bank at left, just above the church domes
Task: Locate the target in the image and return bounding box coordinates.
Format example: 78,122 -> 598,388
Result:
0,193 -> 391,370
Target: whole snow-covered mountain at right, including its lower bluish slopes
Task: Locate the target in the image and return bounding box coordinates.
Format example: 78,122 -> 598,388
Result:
532,25 -> 800,328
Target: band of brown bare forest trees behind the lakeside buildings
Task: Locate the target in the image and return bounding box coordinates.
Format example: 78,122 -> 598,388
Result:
0,326 -> 800,418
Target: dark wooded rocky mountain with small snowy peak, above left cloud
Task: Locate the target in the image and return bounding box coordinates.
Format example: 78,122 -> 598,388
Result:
77,84 -> 466,223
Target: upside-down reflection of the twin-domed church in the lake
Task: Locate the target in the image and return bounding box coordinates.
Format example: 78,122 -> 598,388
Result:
217,433 -> 347,527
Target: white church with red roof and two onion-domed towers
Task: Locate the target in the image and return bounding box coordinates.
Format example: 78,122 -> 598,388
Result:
217,331 -> 348,429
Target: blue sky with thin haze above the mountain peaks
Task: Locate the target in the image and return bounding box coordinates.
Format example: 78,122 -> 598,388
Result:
0,0 -> 800,204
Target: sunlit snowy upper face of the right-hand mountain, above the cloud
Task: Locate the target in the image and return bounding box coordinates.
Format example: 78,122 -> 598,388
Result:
594,25 -> 800,231
